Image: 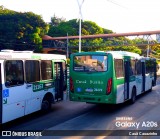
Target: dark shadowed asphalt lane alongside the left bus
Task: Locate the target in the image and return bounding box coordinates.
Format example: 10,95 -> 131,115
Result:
2,101 -> 94,130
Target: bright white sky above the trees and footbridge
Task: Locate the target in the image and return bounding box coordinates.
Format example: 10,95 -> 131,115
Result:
0,0 -> 160,33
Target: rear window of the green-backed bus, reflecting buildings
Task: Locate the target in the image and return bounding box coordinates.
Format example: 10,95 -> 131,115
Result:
73,55 -> 107,72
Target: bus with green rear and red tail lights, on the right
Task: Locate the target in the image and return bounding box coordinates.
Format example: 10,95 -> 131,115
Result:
69,51 -> 156,104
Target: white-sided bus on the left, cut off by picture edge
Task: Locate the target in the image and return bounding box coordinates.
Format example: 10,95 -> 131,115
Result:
0,50 -> 66,124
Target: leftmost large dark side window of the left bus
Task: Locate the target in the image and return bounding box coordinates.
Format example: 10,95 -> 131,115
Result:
5,60 -> 24,87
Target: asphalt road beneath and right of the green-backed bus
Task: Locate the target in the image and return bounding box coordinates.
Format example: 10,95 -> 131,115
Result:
38,85 -> 160,139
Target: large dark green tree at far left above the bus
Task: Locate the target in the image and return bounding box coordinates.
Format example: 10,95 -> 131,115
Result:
0,6 -> 49,51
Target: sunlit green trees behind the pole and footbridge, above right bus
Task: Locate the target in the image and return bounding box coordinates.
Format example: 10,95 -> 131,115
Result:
48,19 -> 141,54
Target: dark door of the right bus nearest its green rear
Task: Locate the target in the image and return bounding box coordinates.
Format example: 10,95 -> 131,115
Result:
124,61 -> 130,100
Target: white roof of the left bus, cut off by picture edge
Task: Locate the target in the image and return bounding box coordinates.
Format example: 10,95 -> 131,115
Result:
0,50 -> 66,60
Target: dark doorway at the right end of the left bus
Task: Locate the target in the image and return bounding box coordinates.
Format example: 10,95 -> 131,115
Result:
54,61 -> 65,101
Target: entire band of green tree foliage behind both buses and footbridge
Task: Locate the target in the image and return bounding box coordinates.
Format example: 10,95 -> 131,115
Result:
0,6 -> 145,54
